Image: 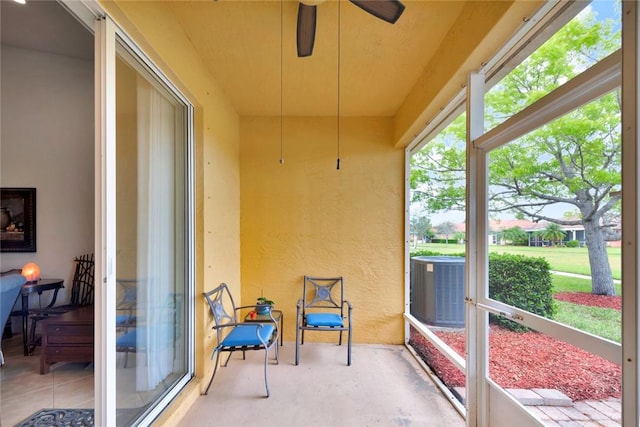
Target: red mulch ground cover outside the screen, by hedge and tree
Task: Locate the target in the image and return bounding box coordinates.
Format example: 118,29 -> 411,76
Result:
410,293 -> 622,401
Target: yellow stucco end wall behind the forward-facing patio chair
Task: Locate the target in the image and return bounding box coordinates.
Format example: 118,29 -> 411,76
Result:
240,117 -> 404,344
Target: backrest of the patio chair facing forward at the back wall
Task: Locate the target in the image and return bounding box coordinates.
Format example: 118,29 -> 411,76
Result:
302,276 -> 344,315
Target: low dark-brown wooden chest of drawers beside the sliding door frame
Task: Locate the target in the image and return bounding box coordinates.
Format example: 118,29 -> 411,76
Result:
40,307 -> 94,375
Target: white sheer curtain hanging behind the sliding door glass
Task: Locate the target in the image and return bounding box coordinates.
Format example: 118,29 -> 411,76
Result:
136,76 -> 176,390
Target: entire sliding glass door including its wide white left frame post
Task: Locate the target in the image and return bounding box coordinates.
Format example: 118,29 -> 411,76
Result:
65,5 -> 194,426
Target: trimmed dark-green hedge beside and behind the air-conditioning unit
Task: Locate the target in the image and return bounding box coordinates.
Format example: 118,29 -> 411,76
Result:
410,250 -> 556,331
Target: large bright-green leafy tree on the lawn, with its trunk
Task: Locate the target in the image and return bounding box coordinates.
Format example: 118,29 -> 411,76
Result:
411,8 -> 621,295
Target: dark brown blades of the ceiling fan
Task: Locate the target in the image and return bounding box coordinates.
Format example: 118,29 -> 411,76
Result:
297,0 -> 404,57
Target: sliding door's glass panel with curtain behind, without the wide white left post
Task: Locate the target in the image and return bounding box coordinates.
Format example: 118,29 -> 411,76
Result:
115,39 -> 189,425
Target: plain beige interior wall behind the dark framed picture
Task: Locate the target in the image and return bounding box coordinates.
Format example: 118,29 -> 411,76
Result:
0,45 -> 94,318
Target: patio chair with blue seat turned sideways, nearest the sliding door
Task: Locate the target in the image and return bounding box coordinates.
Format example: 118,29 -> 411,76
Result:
204,283 -> 278,397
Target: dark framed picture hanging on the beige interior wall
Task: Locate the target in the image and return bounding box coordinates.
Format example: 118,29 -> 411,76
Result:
0,188 -> 36,252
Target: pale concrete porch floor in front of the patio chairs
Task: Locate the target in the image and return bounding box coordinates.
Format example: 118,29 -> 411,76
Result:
180,342 -> 465,427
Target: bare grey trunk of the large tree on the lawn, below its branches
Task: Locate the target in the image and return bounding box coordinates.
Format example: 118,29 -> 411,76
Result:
583,221 -> 616,295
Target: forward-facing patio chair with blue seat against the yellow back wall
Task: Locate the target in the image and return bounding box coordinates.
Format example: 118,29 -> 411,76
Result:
296,276 -> 353,366
